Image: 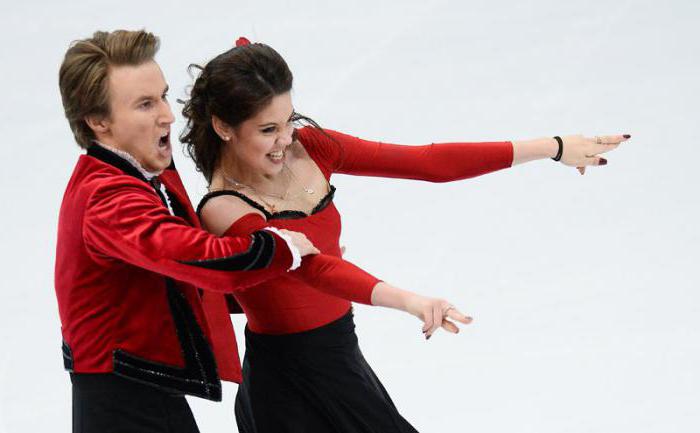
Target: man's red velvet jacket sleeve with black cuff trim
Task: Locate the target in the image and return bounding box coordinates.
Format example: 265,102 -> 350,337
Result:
82,176 -> 292,293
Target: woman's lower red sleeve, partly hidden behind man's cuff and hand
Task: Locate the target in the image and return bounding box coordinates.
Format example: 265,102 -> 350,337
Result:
224,213 -> 381,305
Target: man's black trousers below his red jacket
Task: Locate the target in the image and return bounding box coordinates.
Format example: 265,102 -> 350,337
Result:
71,373 -> 199,433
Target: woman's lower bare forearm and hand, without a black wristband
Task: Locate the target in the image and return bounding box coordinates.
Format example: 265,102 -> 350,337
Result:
372,281 -> 472,339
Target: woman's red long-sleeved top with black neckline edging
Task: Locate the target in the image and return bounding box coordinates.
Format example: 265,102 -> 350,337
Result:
198,127 -> 513,364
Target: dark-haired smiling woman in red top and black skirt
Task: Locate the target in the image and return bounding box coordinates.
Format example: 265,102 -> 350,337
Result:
181,38 -> 627,432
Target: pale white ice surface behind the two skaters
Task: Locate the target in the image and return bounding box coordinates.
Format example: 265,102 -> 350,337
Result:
0,0 -> 700,433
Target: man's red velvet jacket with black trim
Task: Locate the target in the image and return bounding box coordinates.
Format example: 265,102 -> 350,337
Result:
55,144 -> 292,400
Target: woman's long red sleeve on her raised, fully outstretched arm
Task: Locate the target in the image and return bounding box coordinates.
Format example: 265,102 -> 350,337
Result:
297,127 -> 513,182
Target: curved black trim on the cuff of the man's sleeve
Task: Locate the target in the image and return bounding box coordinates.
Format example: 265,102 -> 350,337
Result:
180,230 -> 275,271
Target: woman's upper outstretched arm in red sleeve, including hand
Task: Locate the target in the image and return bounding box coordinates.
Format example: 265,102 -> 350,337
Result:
298,127 -> 626,178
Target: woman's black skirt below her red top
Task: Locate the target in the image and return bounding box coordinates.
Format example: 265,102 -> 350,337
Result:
236,310 -> 417,433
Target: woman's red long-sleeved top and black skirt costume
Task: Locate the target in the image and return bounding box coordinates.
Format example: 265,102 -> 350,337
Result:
198,127 -> 513,433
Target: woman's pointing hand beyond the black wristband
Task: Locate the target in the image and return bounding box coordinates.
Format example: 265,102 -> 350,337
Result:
560,135 -> 630,174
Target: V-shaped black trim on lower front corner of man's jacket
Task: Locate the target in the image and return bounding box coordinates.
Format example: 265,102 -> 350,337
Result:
113,278 -> 221,401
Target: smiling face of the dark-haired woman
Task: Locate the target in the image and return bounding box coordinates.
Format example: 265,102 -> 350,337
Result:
224,92 -> 294,176
